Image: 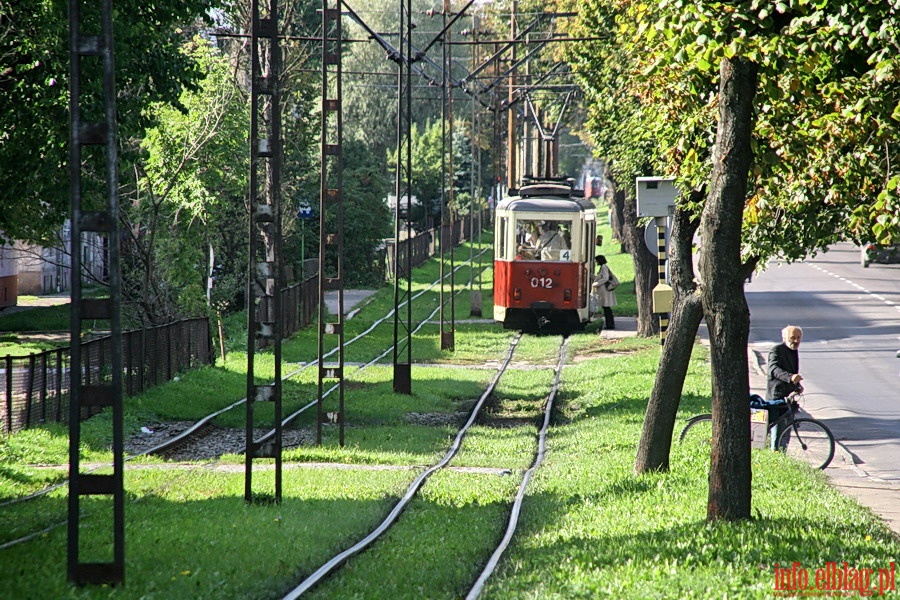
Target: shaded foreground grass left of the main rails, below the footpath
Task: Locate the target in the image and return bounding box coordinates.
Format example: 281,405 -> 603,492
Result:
0,469 -> 410,599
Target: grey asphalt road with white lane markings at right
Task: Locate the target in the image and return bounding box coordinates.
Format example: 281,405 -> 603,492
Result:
745,244 -> 900,487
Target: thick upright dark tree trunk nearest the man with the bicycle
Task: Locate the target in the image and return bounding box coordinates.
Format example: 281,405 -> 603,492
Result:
700,58 -> 757,520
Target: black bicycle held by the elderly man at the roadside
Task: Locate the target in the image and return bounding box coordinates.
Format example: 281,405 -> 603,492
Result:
678,394 -> 834,469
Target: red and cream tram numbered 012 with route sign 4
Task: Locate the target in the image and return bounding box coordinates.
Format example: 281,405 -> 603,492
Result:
494,182 -> 597,331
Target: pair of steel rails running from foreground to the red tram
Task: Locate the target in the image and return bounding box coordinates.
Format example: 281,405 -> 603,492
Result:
283,333 -> 568,600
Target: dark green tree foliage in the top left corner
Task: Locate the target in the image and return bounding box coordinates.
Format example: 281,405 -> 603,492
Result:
0,0 -> 212,242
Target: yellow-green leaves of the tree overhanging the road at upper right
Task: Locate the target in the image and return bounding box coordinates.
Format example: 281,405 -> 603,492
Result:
580,0 -> 900,259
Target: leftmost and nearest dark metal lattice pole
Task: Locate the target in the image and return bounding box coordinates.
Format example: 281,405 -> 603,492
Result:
67,0 -> 125,584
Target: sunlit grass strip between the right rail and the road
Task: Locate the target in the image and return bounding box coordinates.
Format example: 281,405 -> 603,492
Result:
486,351 -> 900,599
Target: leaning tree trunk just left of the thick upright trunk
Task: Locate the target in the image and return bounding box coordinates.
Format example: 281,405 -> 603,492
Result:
634,202 -> 703,473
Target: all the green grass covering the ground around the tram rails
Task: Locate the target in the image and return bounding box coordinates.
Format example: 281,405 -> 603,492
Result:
0,237 -> 900,599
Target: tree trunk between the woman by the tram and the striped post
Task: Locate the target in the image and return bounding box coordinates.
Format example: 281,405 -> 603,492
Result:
616,191 -> 659,337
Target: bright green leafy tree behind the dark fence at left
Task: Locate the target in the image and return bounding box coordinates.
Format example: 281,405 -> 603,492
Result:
130,38 -> 250,325
